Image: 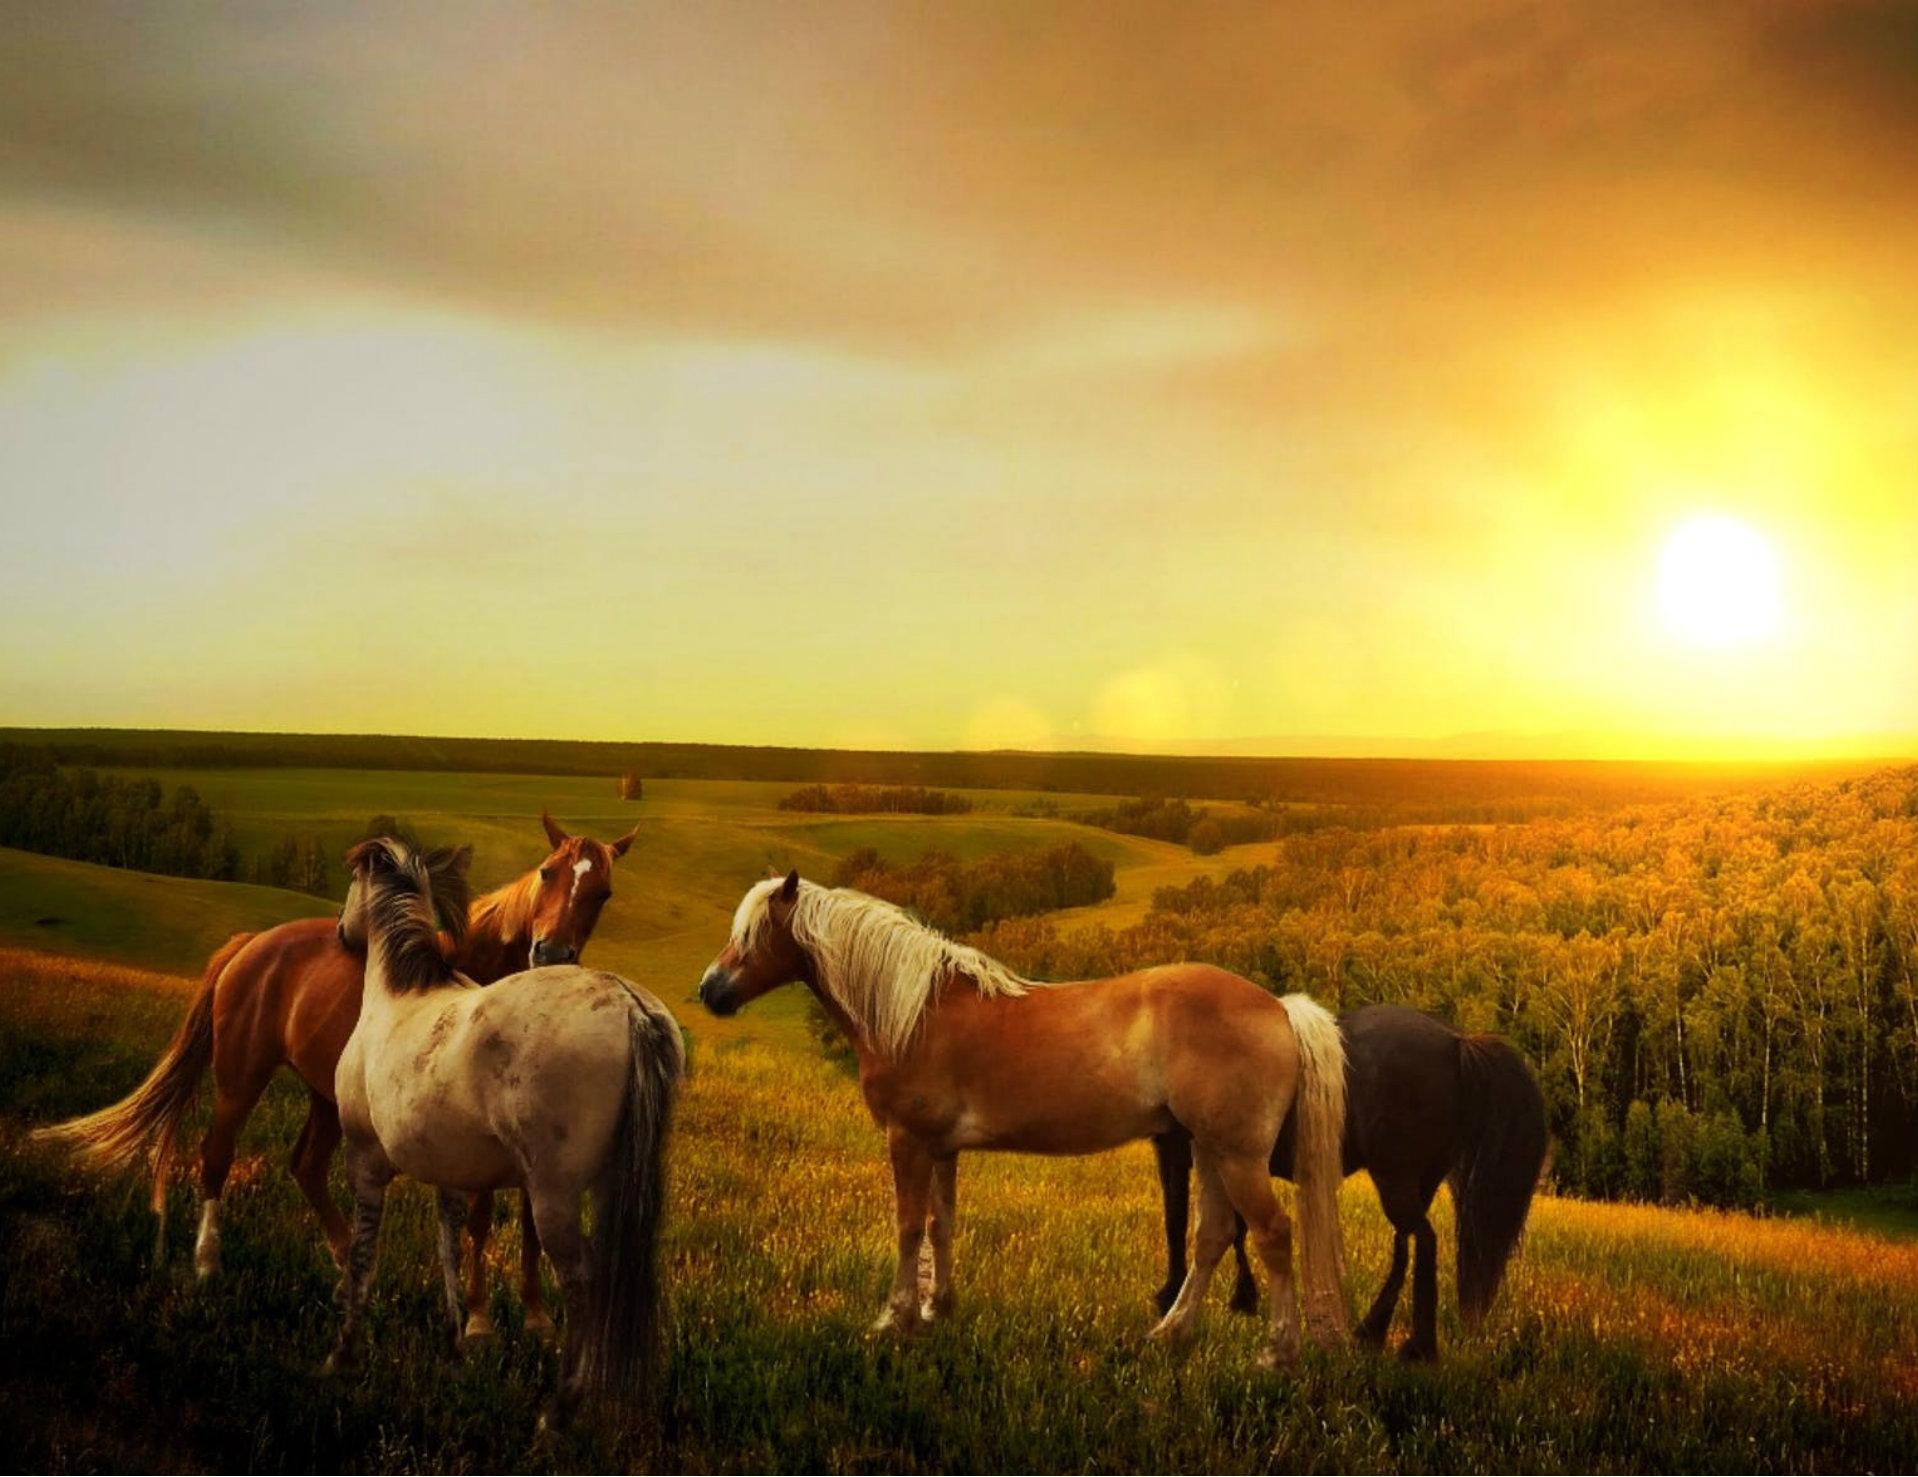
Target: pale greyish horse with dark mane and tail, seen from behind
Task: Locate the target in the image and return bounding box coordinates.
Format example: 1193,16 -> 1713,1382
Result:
332,838 -> 685,1414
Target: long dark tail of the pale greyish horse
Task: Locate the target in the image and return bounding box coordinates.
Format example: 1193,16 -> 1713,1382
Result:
581,986 -> 687,1400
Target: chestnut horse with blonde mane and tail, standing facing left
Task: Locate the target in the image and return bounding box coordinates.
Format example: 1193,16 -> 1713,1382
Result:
700,873 -> 1346,1364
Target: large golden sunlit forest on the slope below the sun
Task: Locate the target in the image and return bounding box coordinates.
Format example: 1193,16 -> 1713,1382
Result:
972,769 -> 1918,1203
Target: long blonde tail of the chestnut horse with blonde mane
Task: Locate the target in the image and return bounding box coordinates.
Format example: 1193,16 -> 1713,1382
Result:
1283,996 -> 1348,1341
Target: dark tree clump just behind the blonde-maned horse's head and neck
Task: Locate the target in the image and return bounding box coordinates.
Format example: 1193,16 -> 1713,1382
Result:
832,842 -> 1112,934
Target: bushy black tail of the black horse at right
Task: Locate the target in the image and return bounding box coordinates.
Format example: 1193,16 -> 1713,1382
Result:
1450,1036 -> 1550,1327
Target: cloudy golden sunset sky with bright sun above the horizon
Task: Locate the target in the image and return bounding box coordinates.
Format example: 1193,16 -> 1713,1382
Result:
0,2 -> 1918,756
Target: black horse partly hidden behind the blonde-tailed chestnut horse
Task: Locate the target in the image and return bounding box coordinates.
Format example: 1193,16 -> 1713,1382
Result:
1153,1005 -> 1548,1360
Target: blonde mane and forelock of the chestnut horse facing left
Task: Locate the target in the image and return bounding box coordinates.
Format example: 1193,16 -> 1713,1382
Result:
733,877 -> 1040,1057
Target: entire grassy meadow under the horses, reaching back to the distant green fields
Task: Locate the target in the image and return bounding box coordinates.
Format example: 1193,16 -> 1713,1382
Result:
0,769 -> 1918,1471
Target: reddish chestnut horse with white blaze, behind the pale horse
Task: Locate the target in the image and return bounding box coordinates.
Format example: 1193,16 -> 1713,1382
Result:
40,815 -> 637,1337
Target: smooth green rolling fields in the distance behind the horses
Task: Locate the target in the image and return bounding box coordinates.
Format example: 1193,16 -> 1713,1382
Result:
0,769 -> 1212,1034
